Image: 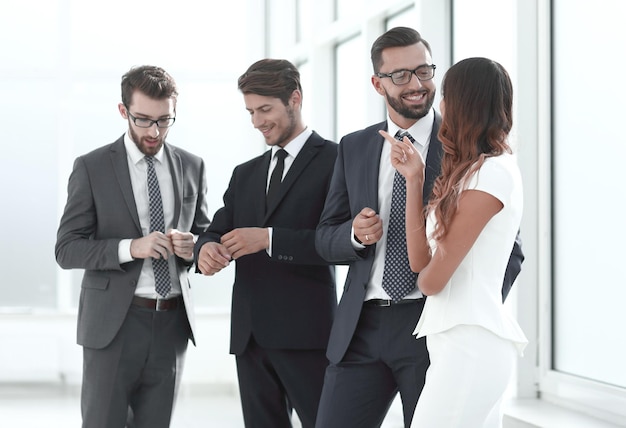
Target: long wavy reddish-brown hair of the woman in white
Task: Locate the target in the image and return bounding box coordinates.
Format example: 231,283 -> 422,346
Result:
428,58 -> 513,239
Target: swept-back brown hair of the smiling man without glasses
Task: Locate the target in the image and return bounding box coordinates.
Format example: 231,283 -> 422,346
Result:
237,58 -> 302,105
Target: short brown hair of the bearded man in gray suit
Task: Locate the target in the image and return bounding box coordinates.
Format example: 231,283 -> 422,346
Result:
122,65 -> 178,107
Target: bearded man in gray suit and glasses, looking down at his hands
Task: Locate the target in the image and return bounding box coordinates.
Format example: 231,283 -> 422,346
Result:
55,66 -> 210,428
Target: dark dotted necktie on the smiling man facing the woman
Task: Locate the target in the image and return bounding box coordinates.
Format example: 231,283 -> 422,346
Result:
383,131 -> 417,301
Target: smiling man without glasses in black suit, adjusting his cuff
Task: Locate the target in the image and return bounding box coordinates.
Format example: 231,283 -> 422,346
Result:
195,59 -> 337,428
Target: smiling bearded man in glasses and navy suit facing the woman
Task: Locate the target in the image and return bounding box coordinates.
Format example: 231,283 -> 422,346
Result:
316,27 -> 523,428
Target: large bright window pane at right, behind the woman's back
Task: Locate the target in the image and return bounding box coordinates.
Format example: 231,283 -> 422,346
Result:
547,0 -> 626,421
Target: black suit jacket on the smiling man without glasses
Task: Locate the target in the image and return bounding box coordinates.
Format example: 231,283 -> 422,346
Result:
195,132 -> 337,355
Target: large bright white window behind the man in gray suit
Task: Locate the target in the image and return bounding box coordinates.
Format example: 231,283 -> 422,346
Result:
0,0 -> 264,313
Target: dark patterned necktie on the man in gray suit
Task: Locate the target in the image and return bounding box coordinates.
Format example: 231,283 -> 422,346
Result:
145,156 -> 172,297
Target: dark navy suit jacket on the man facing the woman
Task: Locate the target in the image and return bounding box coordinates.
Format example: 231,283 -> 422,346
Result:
316,113 -> 523,363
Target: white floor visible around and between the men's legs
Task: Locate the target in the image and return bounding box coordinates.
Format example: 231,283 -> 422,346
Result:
0,385 -> 402,428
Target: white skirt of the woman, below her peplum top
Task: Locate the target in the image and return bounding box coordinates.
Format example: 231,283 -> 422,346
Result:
411,325 -> 517,428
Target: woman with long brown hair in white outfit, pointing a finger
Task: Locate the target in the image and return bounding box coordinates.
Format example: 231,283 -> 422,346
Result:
381,58 -> 527,428
